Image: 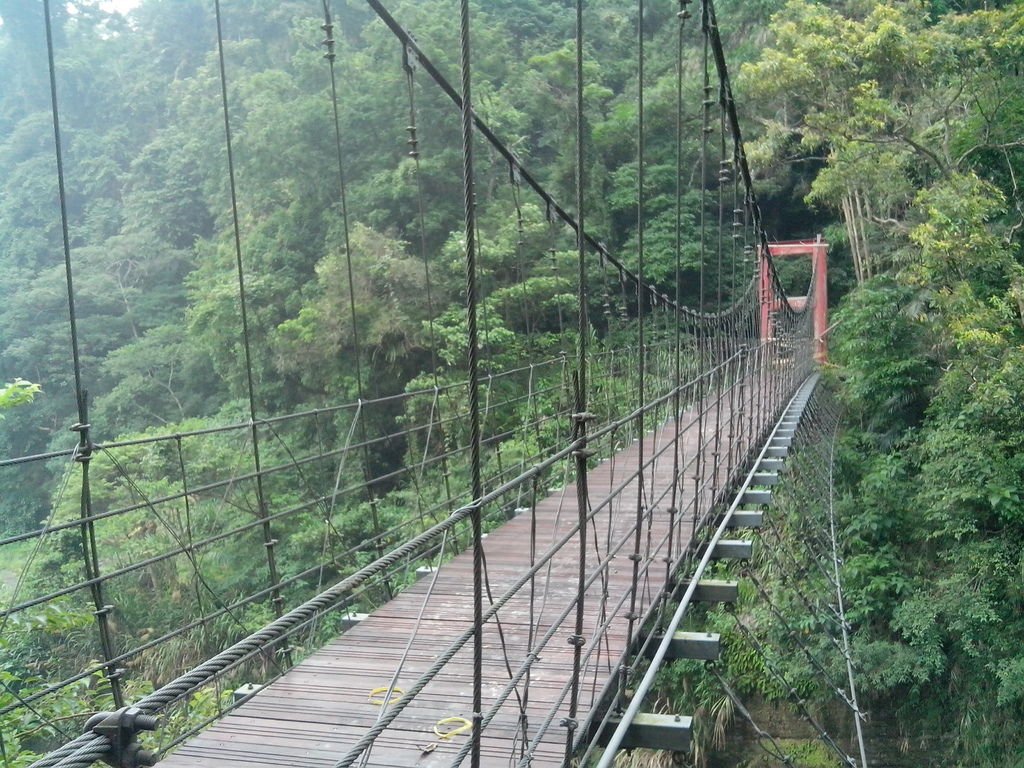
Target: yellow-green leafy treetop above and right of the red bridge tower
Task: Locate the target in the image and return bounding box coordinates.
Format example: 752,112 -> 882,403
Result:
740,0 -> 1024,282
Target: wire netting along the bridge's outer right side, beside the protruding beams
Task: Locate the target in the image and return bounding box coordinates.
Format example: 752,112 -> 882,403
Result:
675,383 -> 867,768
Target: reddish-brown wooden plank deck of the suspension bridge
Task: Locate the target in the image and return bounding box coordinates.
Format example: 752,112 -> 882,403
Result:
161,380 -> 752,768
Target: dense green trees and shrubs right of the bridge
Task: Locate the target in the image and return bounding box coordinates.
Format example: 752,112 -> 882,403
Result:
671,0 -> 1024,766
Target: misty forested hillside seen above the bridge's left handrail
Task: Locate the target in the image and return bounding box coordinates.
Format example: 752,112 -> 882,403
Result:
0,0 -> 770,530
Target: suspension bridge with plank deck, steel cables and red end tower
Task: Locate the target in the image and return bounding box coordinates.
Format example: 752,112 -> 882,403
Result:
0,0 -> 866,768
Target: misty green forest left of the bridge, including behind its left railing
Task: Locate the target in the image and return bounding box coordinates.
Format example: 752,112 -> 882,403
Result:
0,0 -> 745,763
